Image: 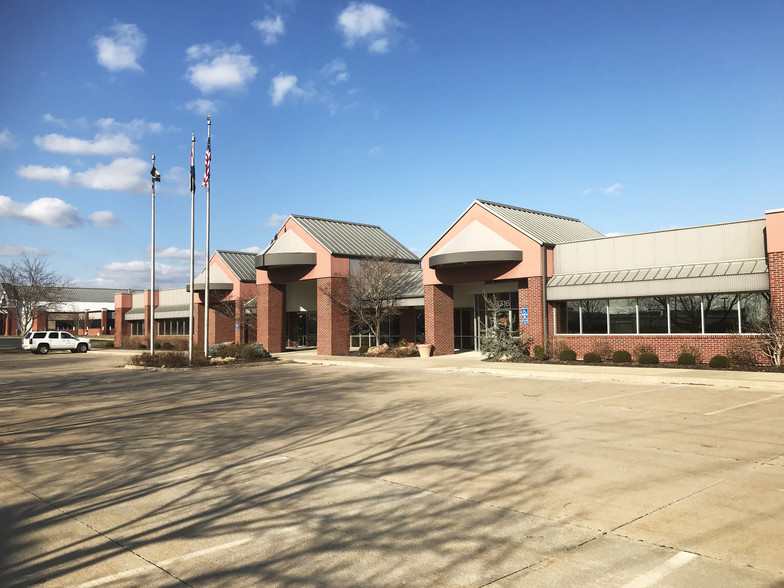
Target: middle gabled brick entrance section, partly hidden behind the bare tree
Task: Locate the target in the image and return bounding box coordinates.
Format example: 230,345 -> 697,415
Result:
256,215 -> 422,355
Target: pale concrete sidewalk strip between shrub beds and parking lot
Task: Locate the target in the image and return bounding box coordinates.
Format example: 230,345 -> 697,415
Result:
273,349 -> 784,393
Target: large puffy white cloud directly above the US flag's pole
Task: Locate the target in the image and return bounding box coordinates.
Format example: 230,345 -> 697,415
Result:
186,45 -> 258,94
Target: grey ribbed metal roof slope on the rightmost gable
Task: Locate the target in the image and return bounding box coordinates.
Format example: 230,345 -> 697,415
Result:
476,200 -> 604,245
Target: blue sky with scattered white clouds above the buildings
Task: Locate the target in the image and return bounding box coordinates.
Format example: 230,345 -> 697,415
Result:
0,0 -> 784,288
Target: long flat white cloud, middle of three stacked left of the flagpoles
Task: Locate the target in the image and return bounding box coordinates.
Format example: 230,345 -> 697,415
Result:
16,157 -> 152,194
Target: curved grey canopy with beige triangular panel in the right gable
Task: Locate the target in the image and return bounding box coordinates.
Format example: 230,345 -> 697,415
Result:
430,221 -> 523,269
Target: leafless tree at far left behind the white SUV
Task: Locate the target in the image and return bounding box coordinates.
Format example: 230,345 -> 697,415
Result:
0,254 -> 69,333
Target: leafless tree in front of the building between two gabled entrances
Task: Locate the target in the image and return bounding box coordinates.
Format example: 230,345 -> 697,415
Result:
322,257 -> 422,344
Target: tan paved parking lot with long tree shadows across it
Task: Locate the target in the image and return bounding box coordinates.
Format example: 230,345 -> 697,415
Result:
0,351 -> 784,588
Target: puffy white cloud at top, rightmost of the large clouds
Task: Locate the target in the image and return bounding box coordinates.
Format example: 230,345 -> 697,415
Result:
337,2 -> 403,53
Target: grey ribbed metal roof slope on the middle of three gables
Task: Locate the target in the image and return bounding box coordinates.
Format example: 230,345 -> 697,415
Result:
291,214 -> 419,261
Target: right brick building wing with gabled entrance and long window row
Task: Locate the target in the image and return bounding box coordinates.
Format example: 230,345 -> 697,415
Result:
423,200 -> 784,360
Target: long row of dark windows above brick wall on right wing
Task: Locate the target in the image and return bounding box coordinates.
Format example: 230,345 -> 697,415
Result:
555,292 -> 770,335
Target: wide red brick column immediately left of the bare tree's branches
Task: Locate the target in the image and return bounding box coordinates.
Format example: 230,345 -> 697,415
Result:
316,276 -> 351,355
